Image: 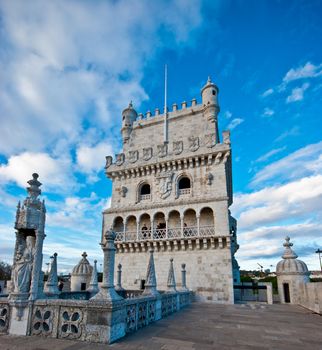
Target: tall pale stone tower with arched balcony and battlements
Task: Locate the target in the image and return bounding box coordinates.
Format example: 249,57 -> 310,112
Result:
102,78 -> 239,303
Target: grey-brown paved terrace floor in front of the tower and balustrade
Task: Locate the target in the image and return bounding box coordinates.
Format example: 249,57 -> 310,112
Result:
0,303 -> 322,350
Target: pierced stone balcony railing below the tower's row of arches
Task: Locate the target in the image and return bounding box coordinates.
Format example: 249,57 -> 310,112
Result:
115,226 -> 215,242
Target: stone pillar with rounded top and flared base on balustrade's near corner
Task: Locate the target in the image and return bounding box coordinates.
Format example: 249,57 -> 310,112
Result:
91,231 -> 123,302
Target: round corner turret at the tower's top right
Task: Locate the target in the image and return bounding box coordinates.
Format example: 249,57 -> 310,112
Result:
201,77 -> 220,142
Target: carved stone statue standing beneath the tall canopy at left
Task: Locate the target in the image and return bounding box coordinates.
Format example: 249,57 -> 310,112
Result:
13,236 -> 34,293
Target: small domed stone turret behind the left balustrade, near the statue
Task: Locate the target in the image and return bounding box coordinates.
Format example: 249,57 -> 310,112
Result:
70,252 -> 93,292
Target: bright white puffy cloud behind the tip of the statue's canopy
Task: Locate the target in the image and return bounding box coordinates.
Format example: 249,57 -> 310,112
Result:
0,152 -> 75,192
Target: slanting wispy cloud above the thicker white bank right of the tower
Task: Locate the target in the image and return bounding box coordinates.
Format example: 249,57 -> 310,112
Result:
251,142 -> 322,186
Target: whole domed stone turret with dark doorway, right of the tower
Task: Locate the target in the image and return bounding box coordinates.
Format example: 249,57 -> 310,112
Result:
276,236 -> 310,304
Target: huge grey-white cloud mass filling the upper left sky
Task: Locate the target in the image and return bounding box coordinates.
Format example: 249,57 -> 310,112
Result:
0,0 -> 201,155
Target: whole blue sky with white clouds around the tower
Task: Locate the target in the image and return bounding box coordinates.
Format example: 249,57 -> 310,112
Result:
0,0 -> 322,271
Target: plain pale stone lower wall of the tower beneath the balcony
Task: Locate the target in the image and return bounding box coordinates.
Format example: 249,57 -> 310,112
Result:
115,248 -> 234,304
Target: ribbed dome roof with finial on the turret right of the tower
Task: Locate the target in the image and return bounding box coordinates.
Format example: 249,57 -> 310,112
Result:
276,237 -> 309,275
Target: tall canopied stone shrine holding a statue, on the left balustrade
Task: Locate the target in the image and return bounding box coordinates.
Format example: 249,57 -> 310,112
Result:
9,173 -> 46,300
